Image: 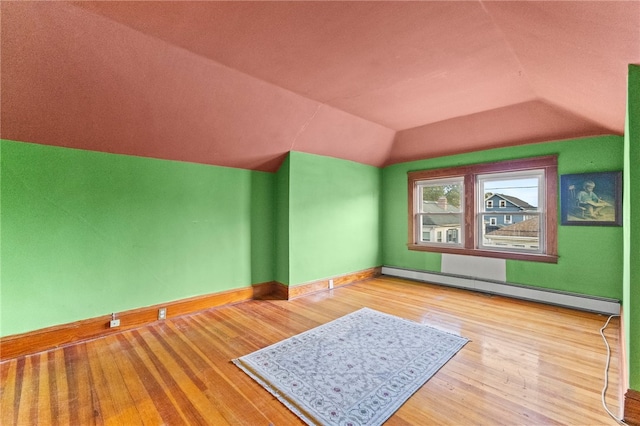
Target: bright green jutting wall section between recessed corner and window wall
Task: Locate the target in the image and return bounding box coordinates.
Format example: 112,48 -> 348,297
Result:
289,152 -> 381,285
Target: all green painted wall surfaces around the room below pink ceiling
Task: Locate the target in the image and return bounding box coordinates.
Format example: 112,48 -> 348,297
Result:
0,130 -> 640,366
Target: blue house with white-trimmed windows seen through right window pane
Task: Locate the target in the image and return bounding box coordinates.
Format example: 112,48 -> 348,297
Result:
483,194 -> 537,234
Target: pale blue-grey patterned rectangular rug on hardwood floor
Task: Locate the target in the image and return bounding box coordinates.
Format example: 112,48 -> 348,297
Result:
233,308 -> 468,425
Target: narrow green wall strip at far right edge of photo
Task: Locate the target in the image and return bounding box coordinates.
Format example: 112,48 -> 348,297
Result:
622,65 -> 640,390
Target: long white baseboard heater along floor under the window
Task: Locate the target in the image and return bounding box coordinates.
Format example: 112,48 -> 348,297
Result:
382,266 -> 620,315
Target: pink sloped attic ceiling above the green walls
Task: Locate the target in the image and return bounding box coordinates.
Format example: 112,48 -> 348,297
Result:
0,1 -> 640,171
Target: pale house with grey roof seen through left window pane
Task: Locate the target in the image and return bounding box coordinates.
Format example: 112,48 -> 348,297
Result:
422,197 -> 462,244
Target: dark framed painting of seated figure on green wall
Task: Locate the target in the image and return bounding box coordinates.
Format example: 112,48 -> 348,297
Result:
560,172 -> 622,226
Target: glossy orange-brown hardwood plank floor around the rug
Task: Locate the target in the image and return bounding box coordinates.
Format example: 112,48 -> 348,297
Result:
0,277 -> 620,426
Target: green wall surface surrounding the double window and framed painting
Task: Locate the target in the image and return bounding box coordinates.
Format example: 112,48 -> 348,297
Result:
382,136 -> 624,299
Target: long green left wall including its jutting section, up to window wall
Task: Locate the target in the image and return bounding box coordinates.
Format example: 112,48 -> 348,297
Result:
0,140 -> 381,336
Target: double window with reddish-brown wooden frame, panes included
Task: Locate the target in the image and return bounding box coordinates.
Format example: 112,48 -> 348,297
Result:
408,156 -> 558,263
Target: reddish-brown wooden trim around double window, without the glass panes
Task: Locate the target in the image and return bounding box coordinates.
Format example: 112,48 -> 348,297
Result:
407,155 -> 558,263
